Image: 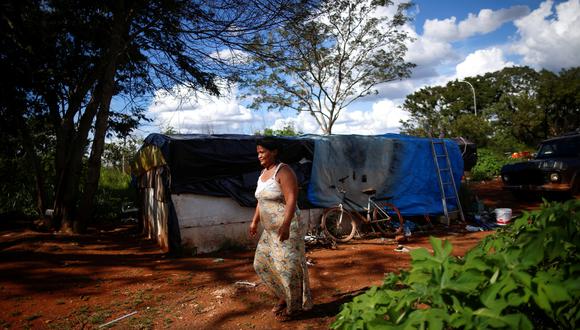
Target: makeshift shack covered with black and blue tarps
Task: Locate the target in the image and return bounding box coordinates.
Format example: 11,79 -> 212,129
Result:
133,134 -> 463,253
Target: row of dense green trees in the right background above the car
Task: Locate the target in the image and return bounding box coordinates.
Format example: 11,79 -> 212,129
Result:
401,67 -> 580,151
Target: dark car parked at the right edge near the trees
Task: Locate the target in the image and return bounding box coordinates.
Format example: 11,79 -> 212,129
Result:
501,131 -> 580,194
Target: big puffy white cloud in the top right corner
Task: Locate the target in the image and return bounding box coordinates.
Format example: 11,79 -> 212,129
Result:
513,0 -> 580,71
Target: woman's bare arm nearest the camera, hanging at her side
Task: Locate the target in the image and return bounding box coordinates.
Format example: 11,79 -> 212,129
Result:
276,165 -> 298,242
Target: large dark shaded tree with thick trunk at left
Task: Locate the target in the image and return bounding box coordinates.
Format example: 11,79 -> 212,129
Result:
0,0 -> 307,232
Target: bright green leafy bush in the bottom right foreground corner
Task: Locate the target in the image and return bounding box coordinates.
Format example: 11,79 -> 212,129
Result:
332,200 -> 580,329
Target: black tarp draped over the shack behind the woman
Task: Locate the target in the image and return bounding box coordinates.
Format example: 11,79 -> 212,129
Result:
144,134 -> 313,208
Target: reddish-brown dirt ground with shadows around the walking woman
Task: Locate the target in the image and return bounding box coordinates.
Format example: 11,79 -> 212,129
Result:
0,182 -> 564,329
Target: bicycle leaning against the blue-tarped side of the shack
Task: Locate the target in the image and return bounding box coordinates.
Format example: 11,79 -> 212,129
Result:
321,176 -> 404,242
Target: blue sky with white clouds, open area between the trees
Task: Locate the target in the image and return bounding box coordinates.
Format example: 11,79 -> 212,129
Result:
140,0 -> 580,134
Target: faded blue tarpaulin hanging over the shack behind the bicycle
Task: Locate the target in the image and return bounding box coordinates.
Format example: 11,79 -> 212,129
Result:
308,134 -> 463,216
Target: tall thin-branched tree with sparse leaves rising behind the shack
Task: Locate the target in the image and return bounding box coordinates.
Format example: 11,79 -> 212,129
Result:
245,0 -> 413,134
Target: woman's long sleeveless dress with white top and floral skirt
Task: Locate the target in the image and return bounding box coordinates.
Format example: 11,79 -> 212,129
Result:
254,164 -> 312,314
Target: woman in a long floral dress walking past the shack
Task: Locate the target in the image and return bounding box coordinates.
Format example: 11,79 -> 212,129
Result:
250,138 -> 312,320
